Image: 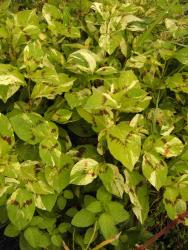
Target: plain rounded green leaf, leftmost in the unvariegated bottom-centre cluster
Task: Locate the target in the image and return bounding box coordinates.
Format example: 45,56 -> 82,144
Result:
71,209 -> 95,227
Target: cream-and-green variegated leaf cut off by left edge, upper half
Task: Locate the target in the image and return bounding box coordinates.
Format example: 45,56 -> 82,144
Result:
0,64 -> 26,102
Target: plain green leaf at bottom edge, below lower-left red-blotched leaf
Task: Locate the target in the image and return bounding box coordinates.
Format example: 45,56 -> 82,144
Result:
24,227 -> 50,248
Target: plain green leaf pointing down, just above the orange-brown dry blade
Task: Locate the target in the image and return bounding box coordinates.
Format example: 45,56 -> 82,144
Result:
99,213 -> 118,245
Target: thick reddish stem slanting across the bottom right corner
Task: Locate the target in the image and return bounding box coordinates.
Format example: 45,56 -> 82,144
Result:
135,211 -> 188,250
